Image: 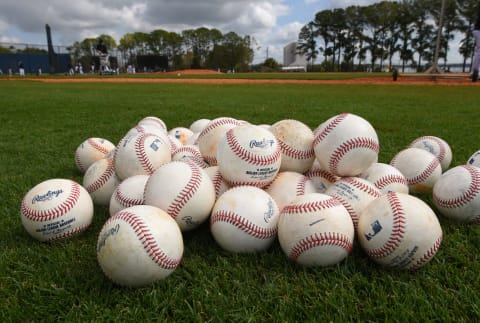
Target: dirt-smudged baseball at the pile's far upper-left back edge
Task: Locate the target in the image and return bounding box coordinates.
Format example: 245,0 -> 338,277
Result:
75,138 -> 115,173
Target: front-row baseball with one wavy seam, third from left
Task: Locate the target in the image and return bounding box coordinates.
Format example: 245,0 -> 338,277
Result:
210,186 -> 279,253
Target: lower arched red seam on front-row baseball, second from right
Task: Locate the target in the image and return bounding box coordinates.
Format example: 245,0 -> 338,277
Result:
288,232 -> 353,261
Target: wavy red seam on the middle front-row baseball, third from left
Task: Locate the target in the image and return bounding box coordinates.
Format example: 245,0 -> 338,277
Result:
211,210 -> 278,239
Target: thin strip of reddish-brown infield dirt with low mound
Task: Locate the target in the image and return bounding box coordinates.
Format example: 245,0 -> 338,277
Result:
9,70 -> 480,86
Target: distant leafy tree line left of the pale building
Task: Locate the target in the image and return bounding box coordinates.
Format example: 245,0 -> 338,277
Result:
68,27 -> 253,71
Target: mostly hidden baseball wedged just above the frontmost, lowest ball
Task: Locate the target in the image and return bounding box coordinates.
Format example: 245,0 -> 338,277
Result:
108,175 -> 149,215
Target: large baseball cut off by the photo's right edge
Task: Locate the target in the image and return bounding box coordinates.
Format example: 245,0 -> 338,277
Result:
433,165 -> 480,224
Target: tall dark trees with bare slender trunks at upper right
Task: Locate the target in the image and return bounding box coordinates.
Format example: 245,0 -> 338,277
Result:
297,0 -> 479,72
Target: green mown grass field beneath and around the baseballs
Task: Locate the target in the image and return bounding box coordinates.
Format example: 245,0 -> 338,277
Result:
0,80 -> 480,322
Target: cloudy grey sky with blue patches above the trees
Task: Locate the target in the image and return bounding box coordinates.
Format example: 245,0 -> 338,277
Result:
0,0 -> 458,63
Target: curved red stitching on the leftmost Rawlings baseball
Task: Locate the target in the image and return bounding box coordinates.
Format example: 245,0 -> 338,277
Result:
21,181 -> 80,221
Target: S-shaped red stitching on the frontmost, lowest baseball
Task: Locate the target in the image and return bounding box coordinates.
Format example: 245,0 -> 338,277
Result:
106,211 -> 182,269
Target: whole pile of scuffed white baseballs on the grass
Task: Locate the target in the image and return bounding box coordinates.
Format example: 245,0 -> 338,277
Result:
21,113 -> 480,287
